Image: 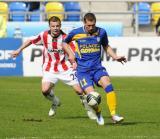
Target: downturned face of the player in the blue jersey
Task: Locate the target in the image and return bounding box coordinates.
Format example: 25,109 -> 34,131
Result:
84,20 -> 96,34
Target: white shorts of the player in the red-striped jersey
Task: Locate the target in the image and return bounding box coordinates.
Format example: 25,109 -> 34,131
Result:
42,69 -> 78,86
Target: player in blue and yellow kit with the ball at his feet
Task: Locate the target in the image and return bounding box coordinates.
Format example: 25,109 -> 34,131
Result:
63,13 -> 126,125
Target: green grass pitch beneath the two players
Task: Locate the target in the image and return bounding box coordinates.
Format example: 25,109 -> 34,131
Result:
0,77 -> 160,139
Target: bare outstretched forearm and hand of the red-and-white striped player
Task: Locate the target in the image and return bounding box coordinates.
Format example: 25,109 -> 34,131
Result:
11,40 -> 32,57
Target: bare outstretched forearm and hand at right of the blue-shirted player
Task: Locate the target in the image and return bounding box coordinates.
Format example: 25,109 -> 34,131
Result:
106,46 -> 127,64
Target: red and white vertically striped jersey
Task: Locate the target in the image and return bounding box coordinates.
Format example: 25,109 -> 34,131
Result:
31,30 -> 74,73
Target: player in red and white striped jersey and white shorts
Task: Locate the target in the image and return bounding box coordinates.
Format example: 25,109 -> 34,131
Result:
11,16 -> 96,119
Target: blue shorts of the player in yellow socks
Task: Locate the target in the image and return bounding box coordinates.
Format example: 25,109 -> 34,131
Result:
77,67 -> 109,90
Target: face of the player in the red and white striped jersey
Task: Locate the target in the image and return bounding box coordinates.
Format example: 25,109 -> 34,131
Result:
49,21 -> 61,37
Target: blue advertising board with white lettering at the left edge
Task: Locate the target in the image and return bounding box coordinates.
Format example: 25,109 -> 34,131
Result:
0,38 -> 23,76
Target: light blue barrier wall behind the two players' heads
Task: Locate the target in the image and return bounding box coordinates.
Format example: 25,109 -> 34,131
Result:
7,22 -> 123,37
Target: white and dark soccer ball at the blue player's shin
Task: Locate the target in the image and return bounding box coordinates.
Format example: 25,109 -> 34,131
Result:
86,92 -> 101,106
